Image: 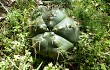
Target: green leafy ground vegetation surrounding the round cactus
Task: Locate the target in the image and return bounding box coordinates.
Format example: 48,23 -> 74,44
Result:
0,0 -> 110,70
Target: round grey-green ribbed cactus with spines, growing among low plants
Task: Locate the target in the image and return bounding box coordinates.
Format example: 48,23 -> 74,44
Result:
32,9 -> 78,58
